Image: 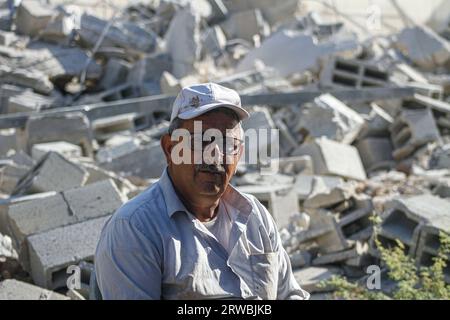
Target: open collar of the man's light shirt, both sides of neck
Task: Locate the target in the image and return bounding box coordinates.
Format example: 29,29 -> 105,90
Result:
158,167 -> 252,218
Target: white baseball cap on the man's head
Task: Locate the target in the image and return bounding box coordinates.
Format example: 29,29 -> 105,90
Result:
170,82 -> 249,122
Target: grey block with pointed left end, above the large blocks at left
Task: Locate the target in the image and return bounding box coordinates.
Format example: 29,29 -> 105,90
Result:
14,152 -> 88,195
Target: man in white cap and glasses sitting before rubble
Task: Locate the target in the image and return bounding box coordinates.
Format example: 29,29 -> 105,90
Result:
95,83 -> 309,299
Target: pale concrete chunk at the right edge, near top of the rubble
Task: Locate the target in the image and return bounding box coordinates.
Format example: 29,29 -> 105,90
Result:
394,26 -> 450,71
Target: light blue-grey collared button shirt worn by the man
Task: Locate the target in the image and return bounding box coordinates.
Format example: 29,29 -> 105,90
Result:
95,169 -> 309,299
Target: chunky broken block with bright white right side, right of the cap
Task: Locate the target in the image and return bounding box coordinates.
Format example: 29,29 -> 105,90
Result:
295,94 -> 364,144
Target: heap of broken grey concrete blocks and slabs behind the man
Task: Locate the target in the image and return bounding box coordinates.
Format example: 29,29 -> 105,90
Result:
0,0 -> 450,299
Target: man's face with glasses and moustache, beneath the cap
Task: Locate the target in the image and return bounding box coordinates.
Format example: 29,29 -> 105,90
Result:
162,112 -> 243,204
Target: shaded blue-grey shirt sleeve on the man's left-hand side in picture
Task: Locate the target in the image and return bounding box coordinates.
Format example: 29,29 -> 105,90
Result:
95,219 -> 162,300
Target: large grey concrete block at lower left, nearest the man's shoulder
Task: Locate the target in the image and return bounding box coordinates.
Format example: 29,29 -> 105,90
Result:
28,216 -> 109,289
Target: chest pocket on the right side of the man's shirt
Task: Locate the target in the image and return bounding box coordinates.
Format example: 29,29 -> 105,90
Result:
250,252 -> 278,300
